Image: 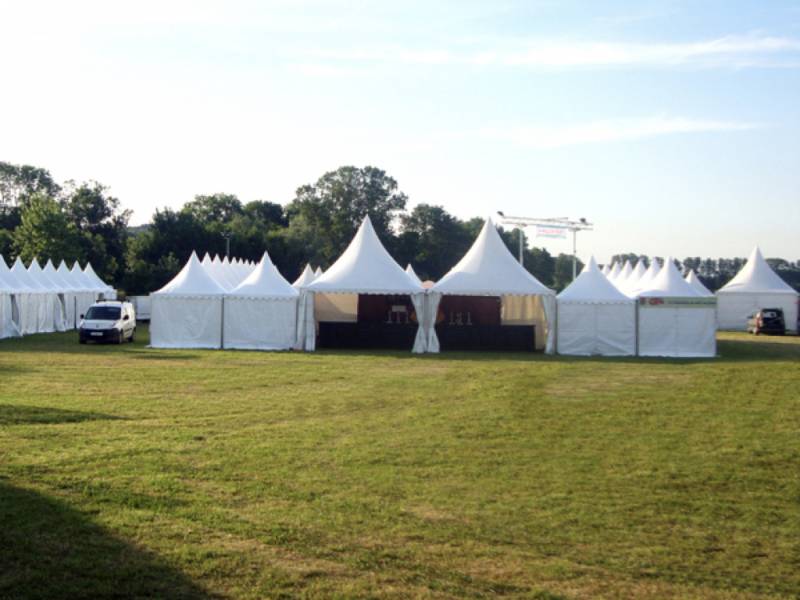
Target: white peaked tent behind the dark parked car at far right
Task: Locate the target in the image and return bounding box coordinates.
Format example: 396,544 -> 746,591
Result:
717,246 -> 798,331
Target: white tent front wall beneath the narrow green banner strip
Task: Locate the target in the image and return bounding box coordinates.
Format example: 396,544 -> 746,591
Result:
639,306 -> 717,358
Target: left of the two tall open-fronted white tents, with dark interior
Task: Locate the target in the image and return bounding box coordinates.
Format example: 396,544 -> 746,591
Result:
297,217 -> 425,352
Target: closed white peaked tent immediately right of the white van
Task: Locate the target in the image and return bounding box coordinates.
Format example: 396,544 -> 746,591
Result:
150,252 -> 225,348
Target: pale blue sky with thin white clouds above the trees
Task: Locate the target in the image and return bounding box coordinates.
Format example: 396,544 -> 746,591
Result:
0,0 -> 800,262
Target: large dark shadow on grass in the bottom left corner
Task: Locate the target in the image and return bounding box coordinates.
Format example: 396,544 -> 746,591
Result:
0,479 -> 214,599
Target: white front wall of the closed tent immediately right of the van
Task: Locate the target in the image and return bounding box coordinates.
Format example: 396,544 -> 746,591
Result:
150,294 -> 222,348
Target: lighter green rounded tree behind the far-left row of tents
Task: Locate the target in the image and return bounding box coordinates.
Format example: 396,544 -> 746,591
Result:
14,193 -> 85,264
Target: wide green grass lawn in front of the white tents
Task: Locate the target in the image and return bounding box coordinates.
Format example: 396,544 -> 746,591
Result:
0,328 -> 800,599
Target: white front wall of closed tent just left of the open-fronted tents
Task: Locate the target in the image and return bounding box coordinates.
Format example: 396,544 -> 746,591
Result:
222,296 -> 297,350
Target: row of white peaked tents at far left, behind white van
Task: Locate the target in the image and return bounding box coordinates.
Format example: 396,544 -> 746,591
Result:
0,256 -> 116,339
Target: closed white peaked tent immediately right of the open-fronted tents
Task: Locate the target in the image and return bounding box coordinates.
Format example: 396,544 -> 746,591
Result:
556,257 -> 636,356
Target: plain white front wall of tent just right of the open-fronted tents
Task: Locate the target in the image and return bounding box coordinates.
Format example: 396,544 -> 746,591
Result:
556,302 -> 636,356
